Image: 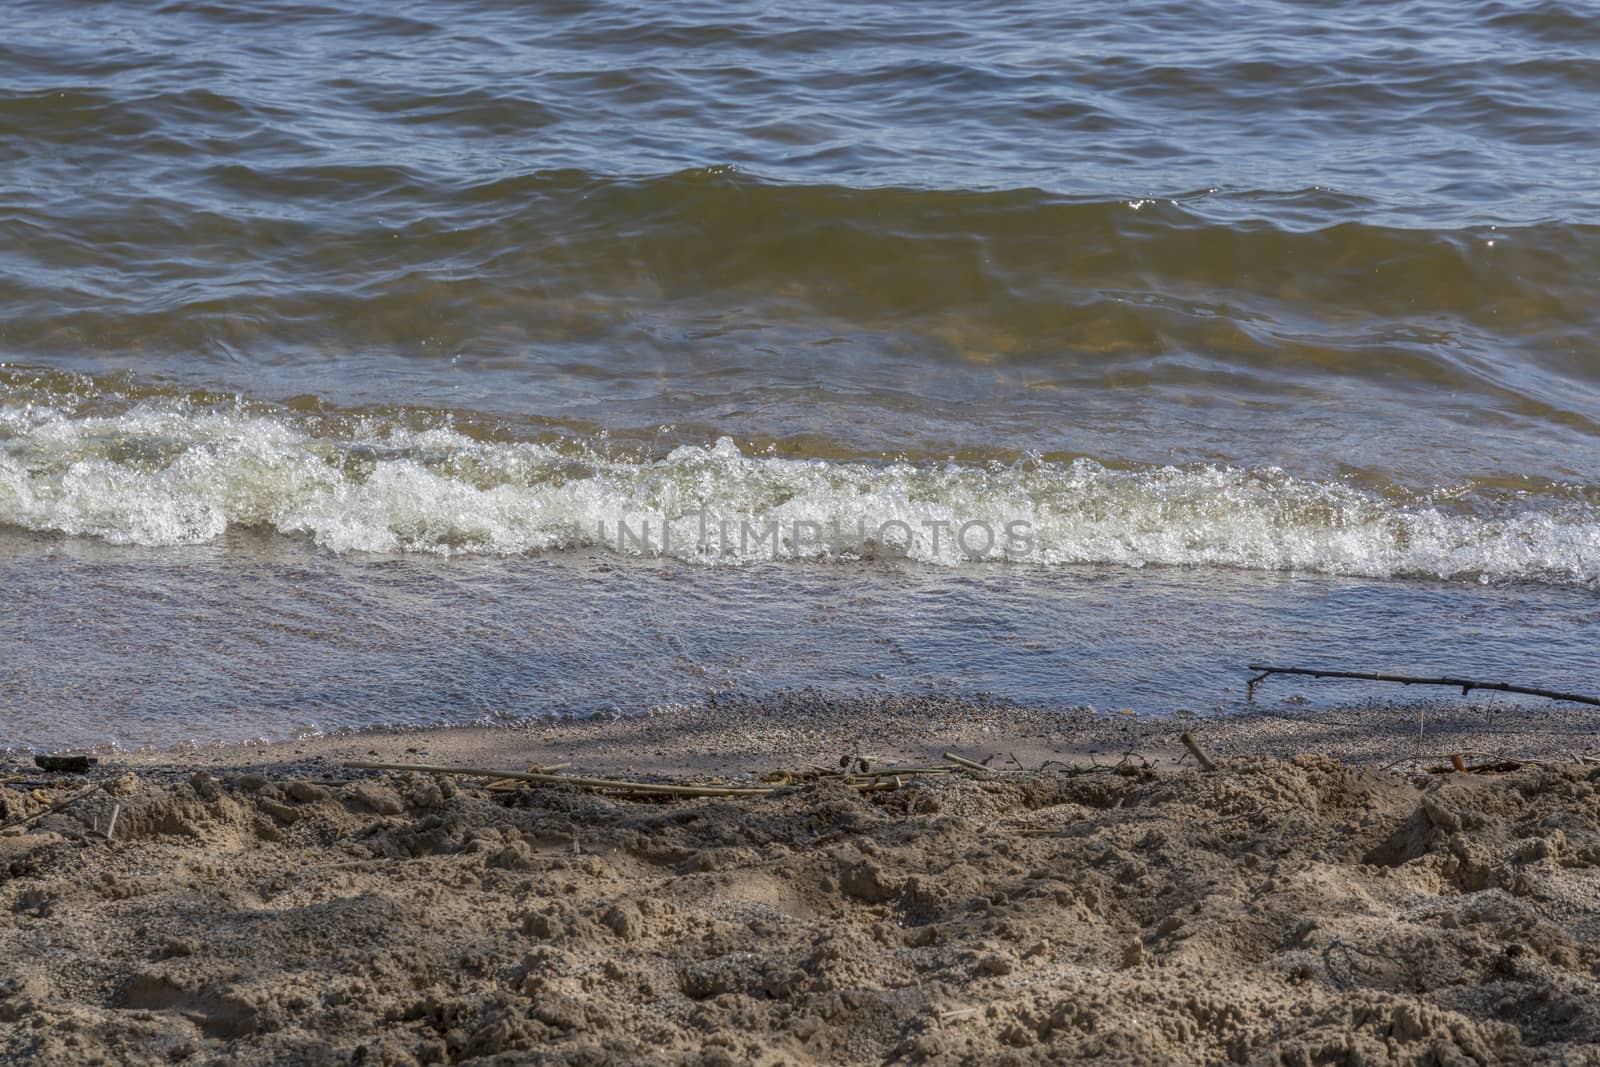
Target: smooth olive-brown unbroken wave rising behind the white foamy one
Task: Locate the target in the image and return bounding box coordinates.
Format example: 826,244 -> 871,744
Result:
6,167 -> 1600,329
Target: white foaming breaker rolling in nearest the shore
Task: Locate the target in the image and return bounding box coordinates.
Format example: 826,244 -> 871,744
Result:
0,402 -> 1600,589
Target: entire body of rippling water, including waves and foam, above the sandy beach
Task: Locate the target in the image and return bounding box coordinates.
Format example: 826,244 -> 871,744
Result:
0,0 -> 1600,744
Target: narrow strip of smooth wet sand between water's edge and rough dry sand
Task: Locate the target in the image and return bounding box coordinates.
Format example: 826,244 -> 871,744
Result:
96,691 -> 1600,776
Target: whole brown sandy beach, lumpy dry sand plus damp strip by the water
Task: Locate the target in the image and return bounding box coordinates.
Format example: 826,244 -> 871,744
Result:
0,694 -> 1600,1064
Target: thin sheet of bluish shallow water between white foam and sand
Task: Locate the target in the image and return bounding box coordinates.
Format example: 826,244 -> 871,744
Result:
0,533 -> 1600,747
